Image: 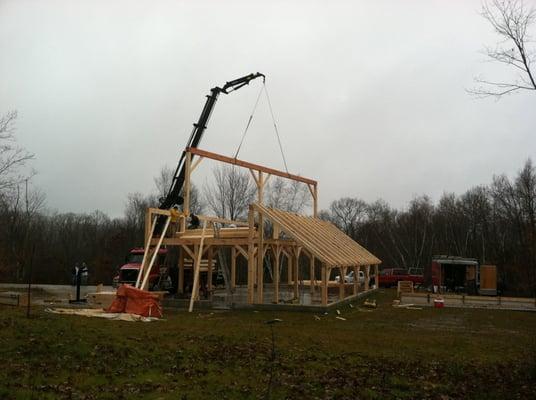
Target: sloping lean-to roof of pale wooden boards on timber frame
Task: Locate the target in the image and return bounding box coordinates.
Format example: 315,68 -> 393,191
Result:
253,203 -> 381,267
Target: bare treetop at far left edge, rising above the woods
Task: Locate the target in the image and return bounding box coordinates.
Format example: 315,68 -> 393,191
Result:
0,111 -> 34,191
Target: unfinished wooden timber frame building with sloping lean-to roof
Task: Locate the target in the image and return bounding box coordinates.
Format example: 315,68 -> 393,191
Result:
145,148 -> 381,311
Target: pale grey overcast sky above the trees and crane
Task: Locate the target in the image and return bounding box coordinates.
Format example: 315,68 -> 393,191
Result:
0,0 -> 536,216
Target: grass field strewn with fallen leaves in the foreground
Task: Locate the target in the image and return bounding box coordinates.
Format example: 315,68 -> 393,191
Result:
0,290 -> 536,400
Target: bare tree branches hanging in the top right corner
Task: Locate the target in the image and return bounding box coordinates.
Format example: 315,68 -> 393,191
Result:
469,0 -> 536,98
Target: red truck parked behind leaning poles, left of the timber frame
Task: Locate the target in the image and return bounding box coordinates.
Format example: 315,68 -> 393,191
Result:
113,247 -> 171,290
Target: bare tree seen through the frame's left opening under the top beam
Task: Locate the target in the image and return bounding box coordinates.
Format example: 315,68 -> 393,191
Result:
205,165 -> 256,220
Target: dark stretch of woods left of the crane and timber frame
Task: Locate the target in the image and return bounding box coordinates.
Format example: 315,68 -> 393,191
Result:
0,195 -> 148,284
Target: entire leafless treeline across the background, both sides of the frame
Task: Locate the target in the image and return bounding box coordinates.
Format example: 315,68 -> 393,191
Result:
0,113 -> 536,295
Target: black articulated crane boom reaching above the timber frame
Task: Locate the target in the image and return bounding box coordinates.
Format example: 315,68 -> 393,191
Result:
159,72 -> 266,210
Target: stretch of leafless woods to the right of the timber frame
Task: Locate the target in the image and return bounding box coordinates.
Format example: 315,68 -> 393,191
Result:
321,160 -> 536,296
